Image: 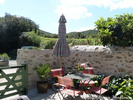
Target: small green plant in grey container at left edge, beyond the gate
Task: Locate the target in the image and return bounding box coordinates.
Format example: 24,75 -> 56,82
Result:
0,53 -> 10,66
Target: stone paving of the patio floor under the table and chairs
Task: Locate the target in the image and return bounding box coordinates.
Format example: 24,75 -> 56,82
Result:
27,88 -> 113,100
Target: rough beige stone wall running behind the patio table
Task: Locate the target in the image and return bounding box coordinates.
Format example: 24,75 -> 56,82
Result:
17,45 -> 133,87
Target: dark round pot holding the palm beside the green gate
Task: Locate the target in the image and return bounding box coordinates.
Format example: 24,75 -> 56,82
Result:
37,81 -> 48,93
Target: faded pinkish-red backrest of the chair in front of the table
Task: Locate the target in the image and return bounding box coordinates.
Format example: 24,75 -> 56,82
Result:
57,76 -> 74,88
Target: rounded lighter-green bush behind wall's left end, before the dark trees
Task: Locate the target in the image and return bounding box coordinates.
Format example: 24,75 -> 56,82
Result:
20,31 -> 41,47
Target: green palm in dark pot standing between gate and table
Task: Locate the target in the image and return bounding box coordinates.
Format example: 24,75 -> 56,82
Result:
35,64 -> 50,93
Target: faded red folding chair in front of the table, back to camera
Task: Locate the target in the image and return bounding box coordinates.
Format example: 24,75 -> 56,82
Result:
57,76 -> 83,99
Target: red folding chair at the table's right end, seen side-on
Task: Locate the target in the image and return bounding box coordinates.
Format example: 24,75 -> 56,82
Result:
88,75 -> 112,99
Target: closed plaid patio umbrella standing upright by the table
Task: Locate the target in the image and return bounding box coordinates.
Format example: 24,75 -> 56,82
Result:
53,14 -> 70,68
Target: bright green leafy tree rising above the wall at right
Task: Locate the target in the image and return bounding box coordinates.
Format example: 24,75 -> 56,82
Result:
95,14 -> 133,47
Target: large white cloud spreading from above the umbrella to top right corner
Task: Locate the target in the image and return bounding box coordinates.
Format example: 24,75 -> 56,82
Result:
55,0 -> 133,19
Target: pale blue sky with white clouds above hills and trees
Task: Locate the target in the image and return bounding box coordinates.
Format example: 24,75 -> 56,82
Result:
0,0 -> 133,34
